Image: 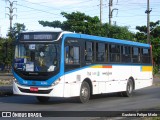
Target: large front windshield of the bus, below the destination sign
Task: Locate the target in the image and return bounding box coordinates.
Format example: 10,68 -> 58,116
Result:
14,43 -> 60,72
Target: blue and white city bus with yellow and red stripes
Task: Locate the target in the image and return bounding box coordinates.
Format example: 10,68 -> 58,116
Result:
13,31 -> 153,103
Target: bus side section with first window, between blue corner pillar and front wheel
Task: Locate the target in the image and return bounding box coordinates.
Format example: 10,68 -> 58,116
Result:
64,39 -> 81,97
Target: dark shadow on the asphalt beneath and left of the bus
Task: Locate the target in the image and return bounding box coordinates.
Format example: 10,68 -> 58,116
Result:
0,92 -> 141,105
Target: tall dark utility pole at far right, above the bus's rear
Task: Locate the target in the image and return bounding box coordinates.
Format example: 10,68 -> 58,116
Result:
145,0 -> 152,44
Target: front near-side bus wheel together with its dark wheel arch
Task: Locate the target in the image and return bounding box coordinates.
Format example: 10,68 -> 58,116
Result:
78,78 -> 92,103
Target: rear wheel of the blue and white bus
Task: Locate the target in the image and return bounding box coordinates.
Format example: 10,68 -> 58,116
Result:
122,79 -> 134,97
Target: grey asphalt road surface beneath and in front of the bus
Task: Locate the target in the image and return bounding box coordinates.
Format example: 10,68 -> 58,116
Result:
0,86 -> 160,120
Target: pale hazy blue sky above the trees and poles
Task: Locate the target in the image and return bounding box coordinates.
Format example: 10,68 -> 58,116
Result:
0,0 -> 160,37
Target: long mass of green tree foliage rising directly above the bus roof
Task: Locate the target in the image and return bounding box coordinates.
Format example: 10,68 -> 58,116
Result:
39,12 -> 134,40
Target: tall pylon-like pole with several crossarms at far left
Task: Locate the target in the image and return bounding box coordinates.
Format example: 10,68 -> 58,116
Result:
6,0 -> 17,32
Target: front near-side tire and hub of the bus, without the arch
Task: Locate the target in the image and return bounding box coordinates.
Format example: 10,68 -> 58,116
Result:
79,81 -> 90,103
